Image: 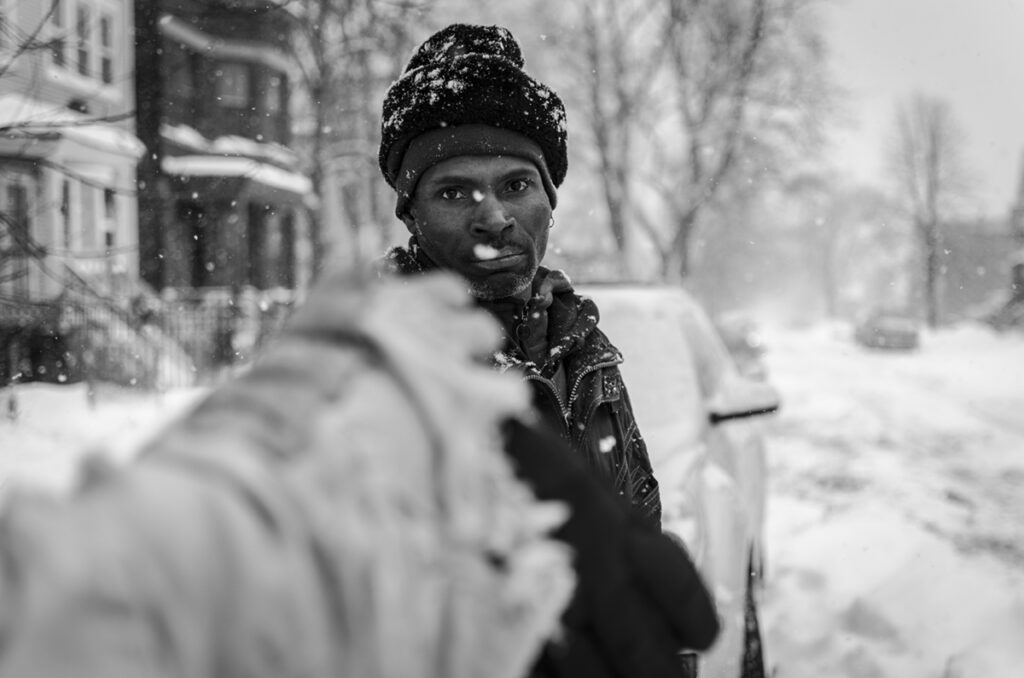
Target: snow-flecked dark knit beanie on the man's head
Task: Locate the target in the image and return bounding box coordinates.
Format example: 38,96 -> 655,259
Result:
378,24 -> 568,218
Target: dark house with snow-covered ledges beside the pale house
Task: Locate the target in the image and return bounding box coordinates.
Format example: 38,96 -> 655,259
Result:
135,0 -> 313,298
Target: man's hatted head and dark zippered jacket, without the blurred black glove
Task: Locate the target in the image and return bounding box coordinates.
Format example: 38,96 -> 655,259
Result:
379,25 -> 660,526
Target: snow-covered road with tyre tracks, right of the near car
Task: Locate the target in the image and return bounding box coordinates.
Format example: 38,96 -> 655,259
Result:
763,328 -> 1024,678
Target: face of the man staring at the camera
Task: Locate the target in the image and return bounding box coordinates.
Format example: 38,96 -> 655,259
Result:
402,156 -> 551,299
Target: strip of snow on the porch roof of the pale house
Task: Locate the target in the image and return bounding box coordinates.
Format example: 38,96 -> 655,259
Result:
0,94 -> 145,158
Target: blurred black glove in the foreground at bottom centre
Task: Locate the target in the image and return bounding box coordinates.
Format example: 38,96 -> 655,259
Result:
505,422 -> 719,678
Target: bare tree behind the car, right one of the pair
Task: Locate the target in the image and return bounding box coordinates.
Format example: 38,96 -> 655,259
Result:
638,0 -> 828,278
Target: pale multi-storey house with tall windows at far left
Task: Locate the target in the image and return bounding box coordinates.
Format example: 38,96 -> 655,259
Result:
0,0 -> 144,303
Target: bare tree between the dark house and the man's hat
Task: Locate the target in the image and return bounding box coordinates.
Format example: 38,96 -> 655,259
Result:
285,0 -> 430,269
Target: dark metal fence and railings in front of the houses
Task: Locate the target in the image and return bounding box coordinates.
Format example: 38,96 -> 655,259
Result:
0,294 -> 292,389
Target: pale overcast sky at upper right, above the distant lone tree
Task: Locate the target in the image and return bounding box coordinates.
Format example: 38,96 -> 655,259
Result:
824,0 -> 1024,216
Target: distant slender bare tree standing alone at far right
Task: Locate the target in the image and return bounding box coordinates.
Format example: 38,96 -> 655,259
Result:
889,93 -> 968,327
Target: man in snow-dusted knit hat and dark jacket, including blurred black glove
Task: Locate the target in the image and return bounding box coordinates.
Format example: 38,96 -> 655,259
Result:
379,24 -> 718,678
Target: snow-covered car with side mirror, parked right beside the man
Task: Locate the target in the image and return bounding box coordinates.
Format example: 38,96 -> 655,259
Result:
578,284 -> 779,678
